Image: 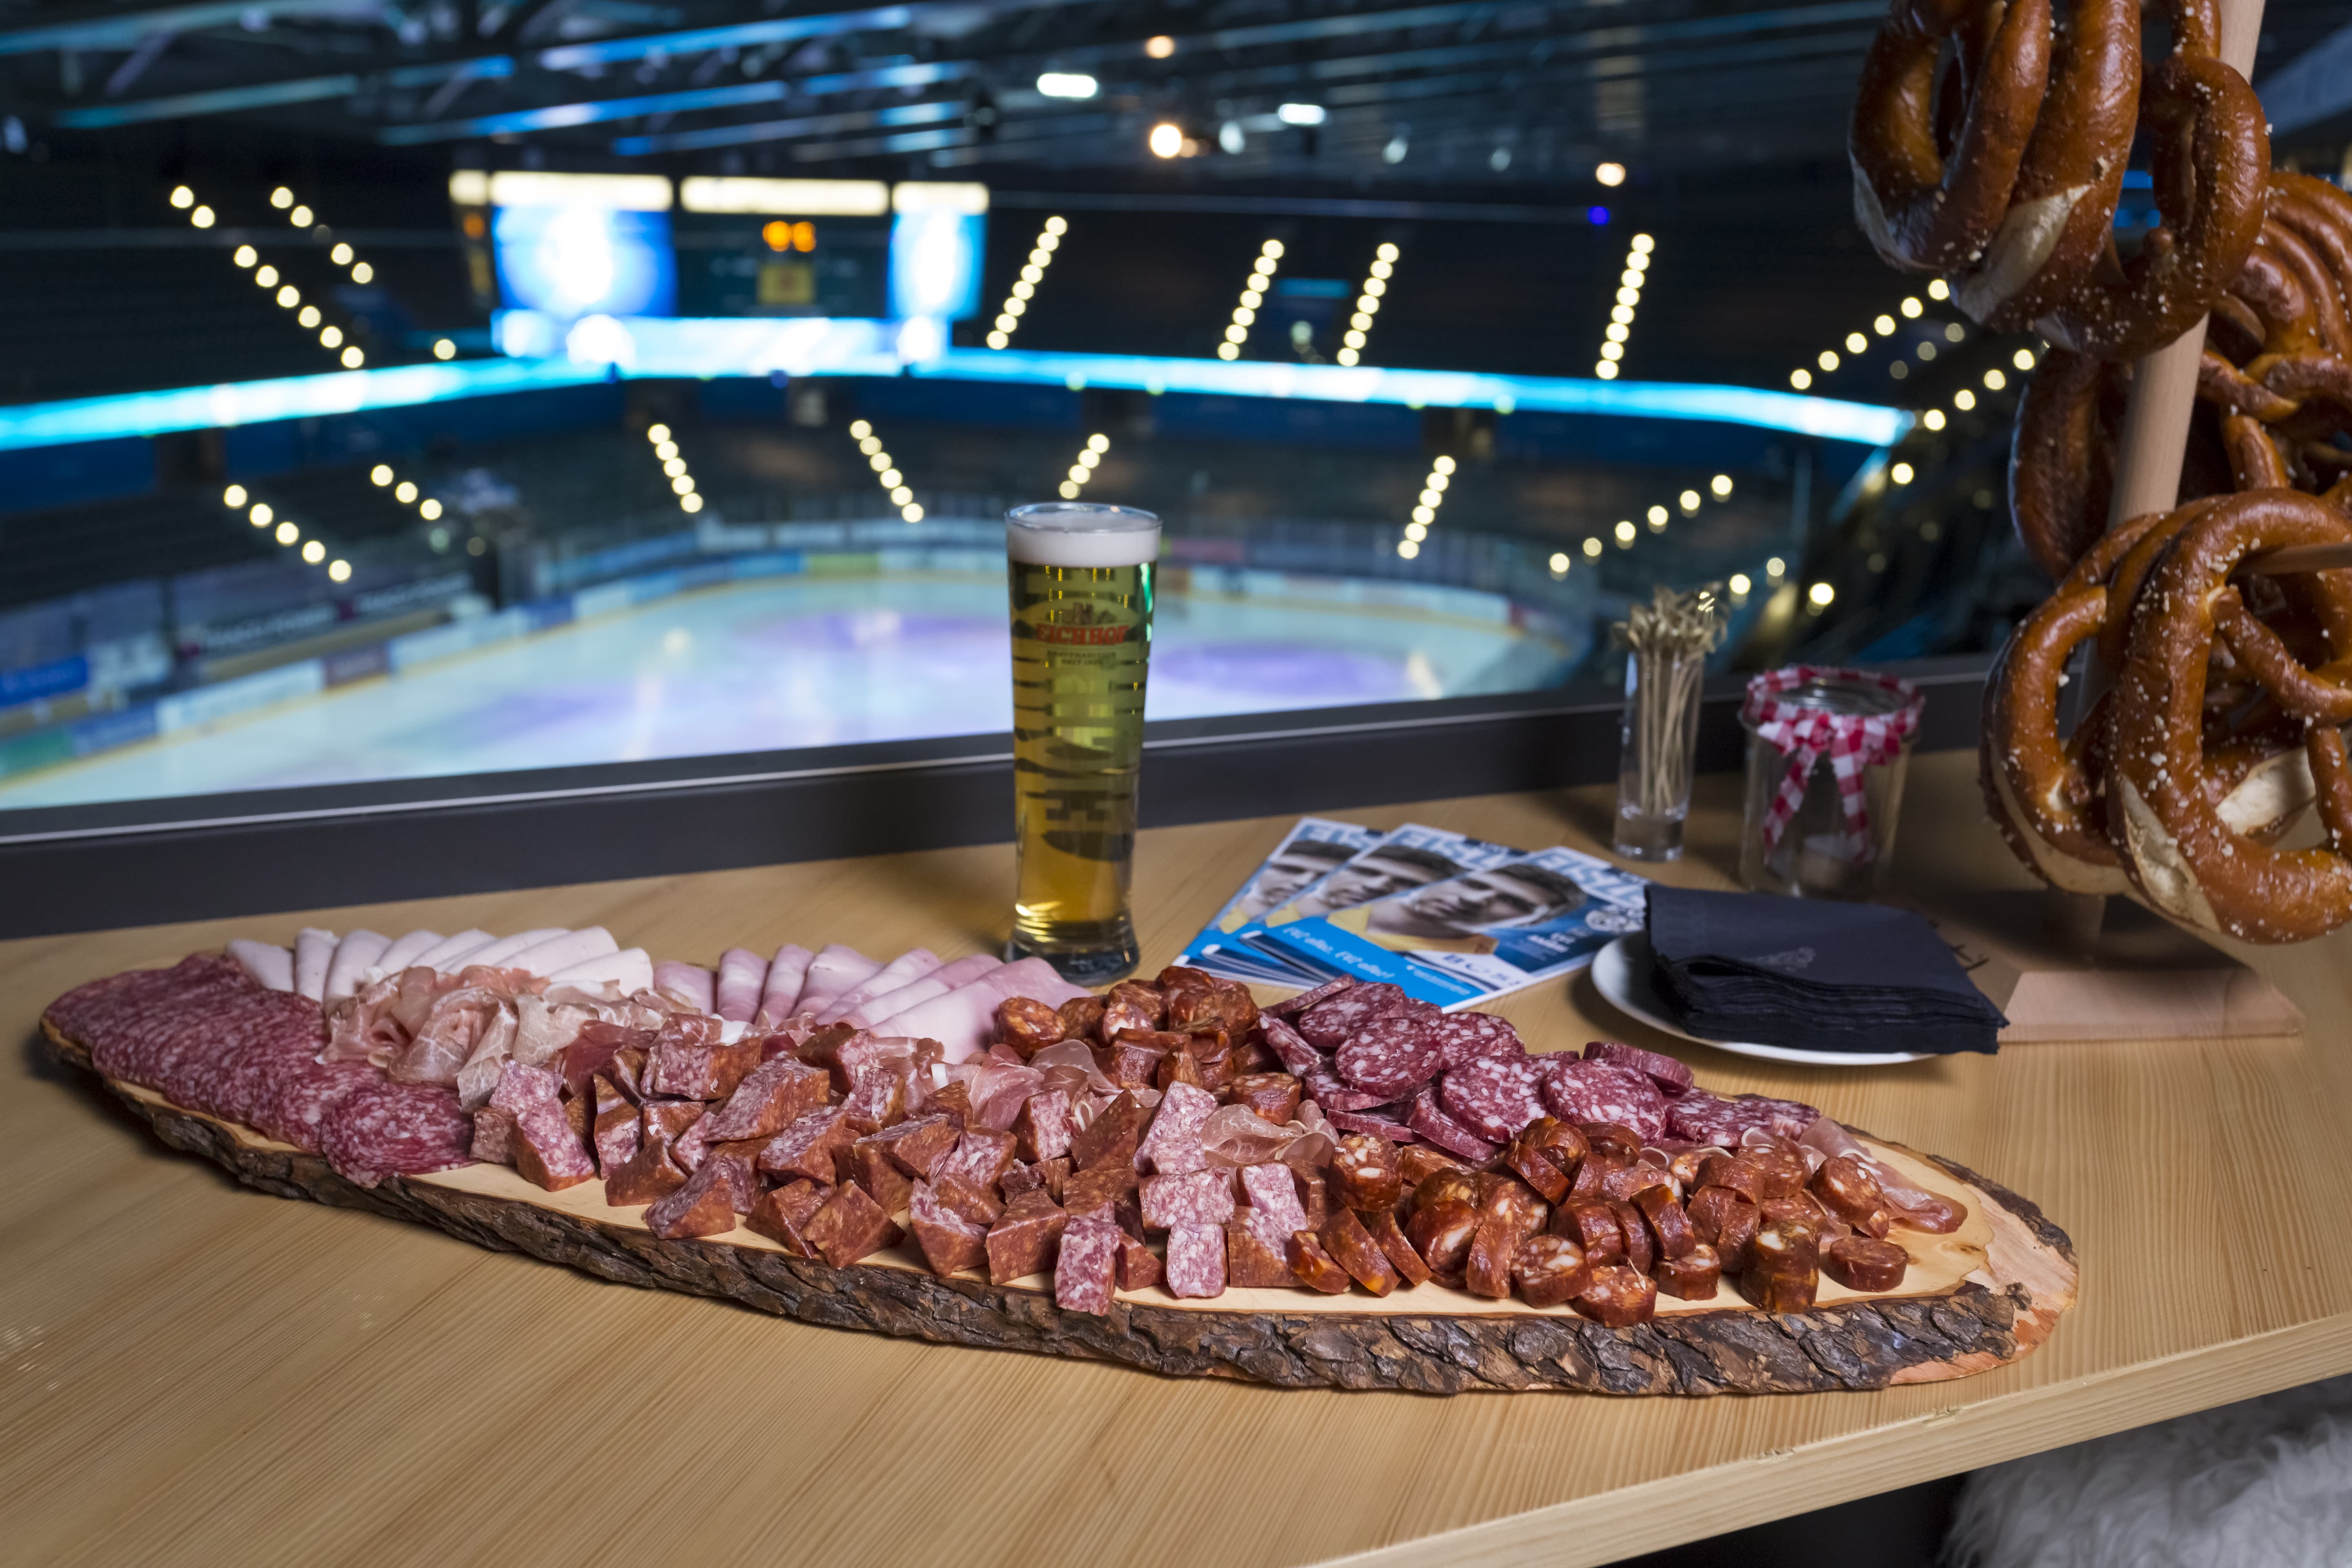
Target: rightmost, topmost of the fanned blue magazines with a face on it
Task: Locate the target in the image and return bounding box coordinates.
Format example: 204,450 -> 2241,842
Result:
1263,849 -> 1646,1009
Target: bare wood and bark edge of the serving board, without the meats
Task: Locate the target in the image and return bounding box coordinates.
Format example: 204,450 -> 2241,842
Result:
42,1018 -> 2077,1394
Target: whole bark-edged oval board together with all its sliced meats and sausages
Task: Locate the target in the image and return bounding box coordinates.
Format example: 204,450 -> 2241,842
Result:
42,931 -> 2077,1394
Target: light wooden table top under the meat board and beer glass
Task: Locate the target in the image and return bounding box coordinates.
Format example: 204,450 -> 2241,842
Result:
0,752 -> 2352,1568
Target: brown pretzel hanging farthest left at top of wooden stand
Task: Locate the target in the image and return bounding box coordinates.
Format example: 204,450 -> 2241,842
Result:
1846,0 -> 2051,273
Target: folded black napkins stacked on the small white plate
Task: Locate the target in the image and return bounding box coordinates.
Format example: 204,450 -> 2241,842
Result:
1649,884 -> 2009,1053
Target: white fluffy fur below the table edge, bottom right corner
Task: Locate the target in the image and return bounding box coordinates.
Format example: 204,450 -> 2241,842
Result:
1945,1378 -> 2352,1568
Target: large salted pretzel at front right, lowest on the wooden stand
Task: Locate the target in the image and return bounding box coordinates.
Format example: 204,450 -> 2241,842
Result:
2105,489 -> 2352,943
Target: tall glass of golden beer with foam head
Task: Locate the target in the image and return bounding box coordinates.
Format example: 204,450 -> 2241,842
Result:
1004,501 -> 1160,985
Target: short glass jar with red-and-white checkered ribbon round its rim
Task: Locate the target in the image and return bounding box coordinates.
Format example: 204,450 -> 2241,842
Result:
1740,665 -> 1922,898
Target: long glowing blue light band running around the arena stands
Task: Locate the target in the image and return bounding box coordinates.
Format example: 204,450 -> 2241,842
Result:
0,329 -> 1912,451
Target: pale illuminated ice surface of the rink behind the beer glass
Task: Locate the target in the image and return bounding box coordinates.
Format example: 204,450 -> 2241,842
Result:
0,574 -> 1548,808
